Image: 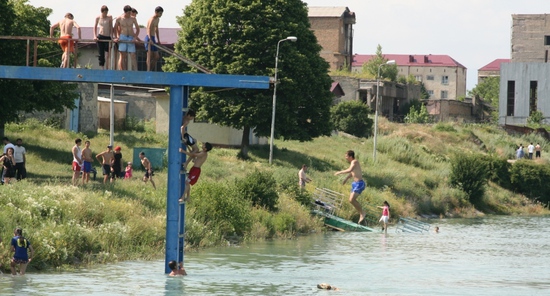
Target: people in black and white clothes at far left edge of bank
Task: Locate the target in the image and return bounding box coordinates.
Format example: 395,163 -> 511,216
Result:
0,137 -> 27,185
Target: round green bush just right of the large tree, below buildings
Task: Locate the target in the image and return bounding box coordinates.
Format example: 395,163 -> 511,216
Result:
330,101 -> 373,137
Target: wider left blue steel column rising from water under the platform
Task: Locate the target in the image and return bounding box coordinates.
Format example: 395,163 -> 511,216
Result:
164,85 -> 183,273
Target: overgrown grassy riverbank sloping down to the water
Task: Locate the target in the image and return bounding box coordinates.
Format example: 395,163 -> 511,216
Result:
0,120 -> 549,268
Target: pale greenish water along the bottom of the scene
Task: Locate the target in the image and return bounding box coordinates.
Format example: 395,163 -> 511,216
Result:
0,217 -> 550,295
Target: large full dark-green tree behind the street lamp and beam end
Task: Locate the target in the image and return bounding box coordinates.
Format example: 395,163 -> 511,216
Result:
164,0 -> 333,156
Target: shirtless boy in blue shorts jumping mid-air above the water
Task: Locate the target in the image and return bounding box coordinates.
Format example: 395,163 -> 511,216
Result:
334,150 -> 366,224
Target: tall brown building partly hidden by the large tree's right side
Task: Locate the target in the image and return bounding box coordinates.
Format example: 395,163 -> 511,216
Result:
308,6 -> 355,70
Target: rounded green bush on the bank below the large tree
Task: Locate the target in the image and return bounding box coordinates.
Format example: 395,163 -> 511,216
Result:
235,170 -> 279,211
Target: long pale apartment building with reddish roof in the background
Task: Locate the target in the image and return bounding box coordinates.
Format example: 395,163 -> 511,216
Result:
352,54 -> 466,100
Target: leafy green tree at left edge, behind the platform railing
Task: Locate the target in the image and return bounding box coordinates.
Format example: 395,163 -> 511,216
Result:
0,0 -> 76,136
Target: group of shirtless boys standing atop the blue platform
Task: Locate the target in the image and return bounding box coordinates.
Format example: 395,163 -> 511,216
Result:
50,5 -> 164,71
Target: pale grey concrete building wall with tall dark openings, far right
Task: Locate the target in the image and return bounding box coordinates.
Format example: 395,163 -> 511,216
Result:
498,63 -> 550,125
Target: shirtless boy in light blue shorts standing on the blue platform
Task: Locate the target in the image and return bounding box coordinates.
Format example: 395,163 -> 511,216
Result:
114,5 -> 139,70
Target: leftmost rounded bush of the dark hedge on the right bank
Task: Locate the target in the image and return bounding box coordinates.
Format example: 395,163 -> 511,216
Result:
449,154 -> 487,205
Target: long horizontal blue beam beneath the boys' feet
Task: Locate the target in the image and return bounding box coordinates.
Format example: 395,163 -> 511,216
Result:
0,66 -> 269,89
